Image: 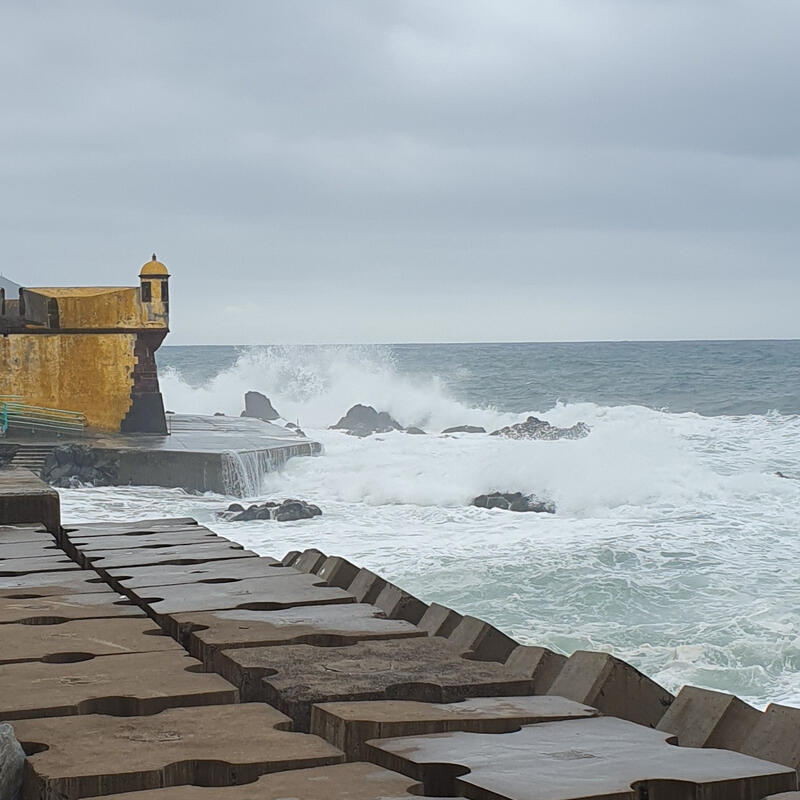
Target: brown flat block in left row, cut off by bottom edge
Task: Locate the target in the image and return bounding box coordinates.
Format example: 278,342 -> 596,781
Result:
71,763 -> 417,800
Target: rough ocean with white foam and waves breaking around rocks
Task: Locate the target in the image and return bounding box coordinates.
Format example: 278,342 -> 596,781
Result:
57,341 -> 800,706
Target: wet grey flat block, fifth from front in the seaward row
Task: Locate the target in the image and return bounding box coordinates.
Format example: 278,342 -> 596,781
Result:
129,572 -> 354,636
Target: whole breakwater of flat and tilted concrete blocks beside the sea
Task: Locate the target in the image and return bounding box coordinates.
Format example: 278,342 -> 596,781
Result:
0,510 -> 800,800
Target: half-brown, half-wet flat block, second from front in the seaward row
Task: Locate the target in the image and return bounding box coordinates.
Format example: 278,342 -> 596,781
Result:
311,696 -> 597,759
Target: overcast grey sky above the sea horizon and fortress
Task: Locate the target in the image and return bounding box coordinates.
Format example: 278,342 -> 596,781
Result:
0,0 -> 800,344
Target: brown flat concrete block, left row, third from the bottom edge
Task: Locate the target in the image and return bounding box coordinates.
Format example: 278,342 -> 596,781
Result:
0,651 -> 239,720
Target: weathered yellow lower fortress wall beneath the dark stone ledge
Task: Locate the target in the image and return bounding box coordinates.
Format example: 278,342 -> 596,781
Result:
0,332 -> 136,431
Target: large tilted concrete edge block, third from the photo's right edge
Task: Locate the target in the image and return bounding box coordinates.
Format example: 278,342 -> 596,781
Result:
547,650 -> 674,727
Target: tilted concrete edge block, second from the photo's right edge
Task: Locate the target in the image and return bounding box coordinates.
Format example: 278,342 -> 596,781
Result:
656,686 -> 763,751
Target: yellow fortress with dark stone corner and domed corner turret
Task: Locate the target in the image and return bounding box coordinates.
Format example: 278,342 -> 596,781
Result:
0,253 -> 170,434
